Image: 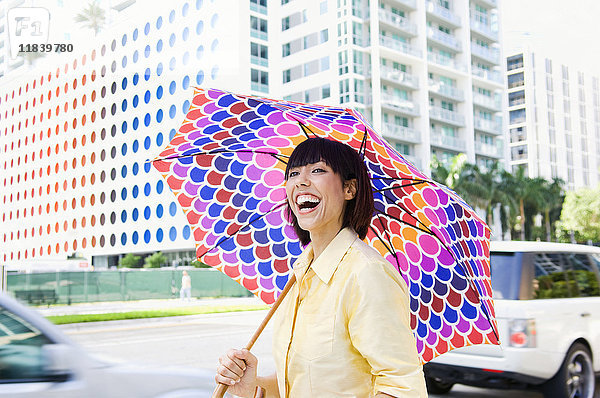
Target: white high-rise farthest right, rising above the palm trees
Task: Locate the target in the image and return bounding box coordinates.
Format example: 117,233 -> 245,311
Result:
506,50 -> 600,190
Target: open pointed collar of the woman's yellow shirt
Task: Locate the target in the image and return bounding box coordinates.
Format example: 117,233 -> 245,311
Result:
294,228 -> 358,284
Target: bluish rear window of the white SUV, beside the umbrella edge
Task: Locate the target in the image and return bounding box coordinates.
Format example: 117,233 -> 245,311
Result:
490,252 -> 522,300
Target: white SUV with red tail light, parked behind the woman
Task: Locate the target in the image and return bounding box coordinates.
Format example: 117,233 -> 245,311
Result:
425,242 -> 600,398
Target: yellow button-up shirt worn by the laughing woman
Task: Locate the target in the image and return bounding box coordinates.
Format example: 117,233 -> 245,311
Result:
273,228 -> 427,398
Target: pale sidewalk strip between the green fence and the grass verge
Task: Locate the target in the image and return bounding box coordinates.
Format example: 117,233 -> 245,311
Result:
33,296 -> 265,316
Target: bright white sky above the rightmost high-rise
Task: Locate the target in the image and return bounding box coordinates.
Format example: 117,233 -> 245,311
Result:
499,0 -> 600,76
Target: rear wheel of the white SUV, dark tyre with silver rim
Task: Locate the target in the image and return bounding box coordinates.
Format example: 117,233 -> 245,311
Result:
544,343 -> 596,398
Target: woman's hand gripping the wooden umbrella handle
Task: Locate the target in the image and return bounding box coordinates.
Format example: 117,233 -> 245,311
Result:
215,349 -> 258,398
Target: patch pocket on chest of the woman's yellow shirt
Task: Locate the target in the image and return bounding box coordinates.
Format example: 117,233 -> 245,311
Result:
292,314 -> 335,361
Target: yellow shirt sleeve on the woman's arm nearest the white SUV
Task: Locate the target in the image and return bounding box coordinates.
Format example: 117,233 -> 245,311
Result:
345,261 -> 427,398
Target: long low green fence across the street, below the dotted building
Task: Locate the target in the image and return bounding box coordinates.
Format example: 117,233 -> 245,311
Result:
7,269 -> 252,304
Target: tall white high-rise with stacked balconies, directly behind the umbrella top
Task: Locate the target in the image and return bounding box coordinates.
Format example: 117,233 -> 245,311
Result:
269,0 -> 505,169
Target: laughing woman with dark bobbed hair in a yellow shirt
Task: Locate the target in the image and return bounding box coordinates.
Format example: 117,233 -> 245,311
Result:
215,138 -> 427,398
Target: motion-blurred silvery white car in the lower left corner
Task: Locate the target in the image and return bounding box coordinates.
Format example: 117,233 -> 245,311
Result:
0,294 -> 214,398
